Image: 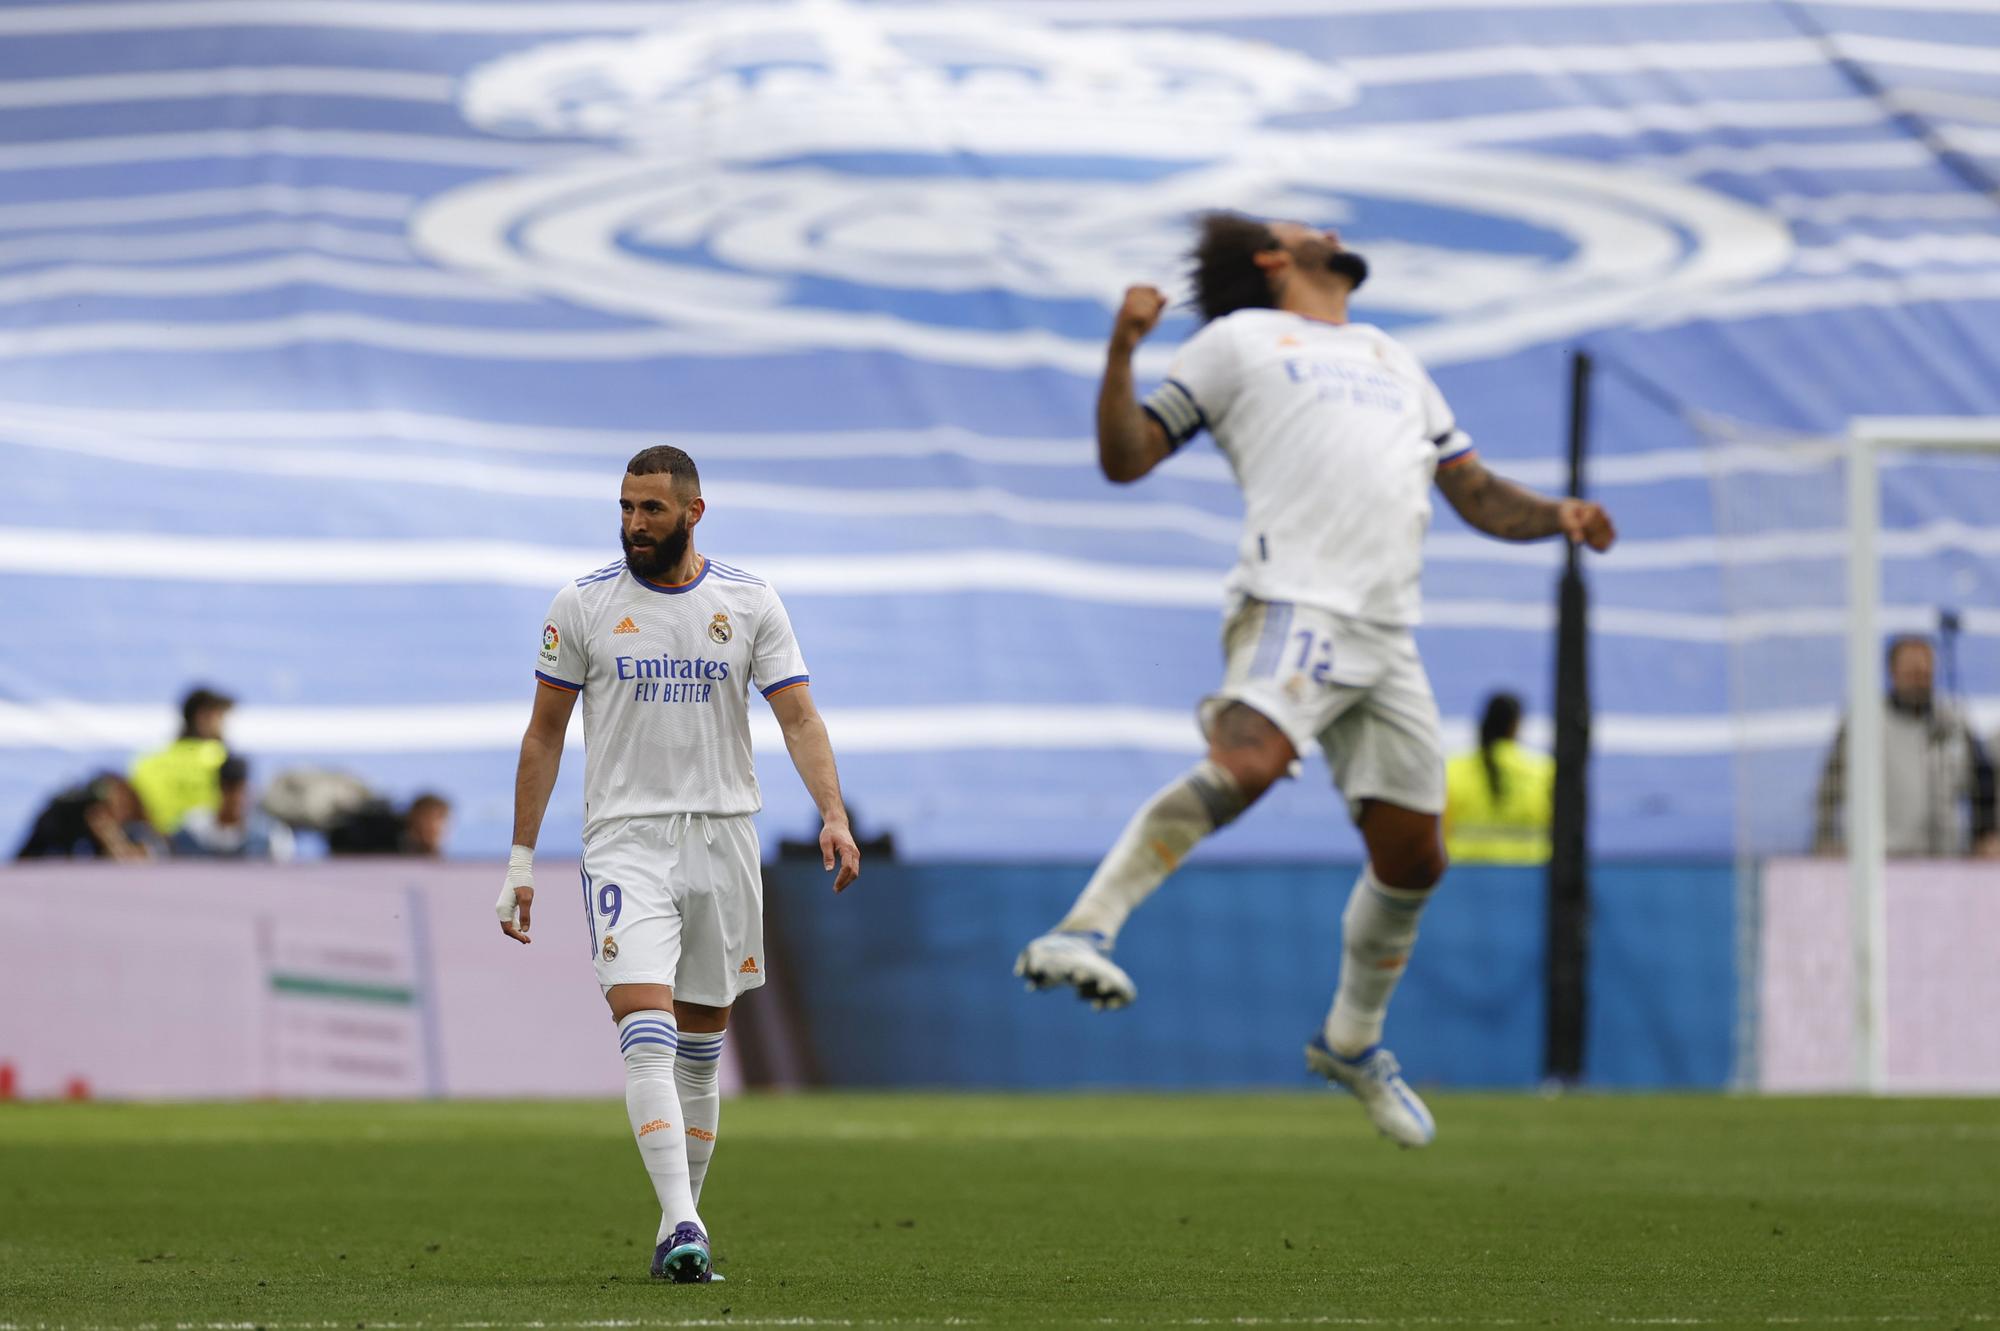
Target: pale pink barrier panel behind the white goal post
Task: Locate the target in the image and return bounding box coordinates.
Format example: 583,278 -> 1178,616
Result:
1758,859 -> 2000,1093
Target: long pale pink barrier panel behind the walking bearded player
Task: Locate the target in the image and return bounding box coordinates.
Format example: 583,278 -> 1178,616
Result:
0,859 -> 740,1099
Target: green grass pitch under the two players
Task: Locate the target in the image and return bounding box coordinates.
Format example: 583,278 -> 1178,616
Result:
0,1093 -> 2000,1331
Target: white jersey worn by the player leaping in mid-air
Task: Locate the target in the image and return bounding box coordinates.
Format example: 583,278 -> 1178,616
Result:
1144,310 -> 1472,624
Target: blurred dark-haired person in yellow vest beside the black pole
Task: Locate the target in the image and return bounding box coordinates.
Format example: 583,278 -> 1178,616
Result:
1444,693 -> 1556,863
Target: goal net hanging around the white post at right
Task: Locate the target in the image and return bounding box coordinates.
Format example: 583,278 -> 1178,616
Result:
1702,418 -> 2000,1091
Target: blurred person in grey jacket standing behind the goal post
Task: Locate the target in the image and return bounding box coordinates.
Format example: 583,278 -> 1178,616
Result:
1812,634 -> 2000,855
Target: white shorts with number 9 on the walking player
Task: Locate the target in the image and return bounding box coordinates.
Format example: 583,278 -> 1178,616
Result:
584,813 -> 766,1007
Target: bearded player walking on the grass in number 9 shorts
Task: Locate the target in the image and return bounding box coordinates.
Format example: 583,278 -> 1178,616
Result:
498,446 -> 862,1283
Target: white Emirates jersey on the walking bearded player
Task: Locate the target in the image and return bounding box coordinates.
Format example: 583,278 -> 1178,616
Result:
534,560 -> 810,833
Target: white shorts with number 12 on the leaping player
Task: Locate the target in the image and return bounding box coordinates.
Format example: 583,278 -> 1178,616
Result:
1200,598 -> 1444,817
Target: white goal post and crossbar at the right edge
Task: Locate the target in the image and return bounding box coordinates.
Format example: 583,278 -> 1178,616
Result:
1846,416 -> 2000,1093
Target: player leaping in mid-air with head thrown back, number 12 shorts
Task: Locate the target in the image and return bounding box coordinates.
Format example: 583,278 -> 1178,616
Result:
1014,212 -> 1616,1147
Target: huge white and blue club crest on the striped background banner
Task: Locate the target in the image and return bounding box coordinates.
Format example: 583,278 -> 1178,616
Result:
410,0 -> 1792,376
